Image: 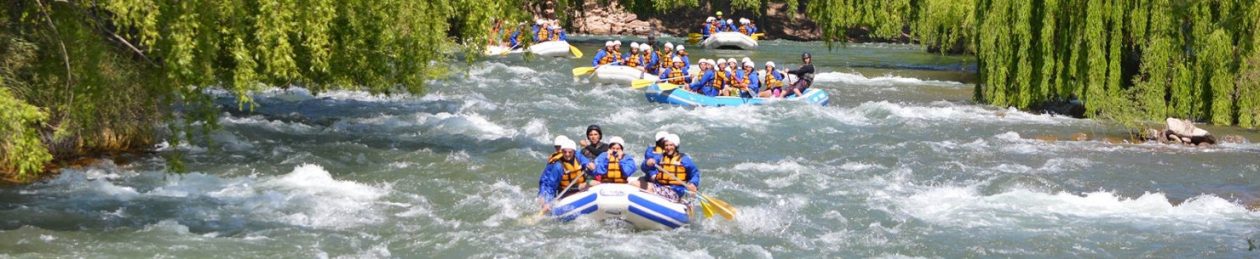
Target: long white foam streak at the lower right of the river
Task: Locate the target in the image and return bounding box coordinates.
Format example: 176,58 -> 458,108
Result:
895,186 -> 1260,229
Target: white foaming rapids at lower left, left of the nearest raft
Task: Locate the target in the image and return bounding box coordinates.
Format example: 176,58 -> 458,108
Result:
44,165 -> 389,229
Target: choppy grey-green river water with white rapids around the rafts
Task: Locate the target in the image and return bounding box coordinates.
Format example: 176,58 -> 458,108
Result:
0,38 -> 1260,258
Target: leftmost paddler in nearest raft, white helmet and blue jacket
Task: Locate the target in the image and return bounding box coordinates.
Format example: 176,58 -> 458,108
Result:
538,137 -> 595,211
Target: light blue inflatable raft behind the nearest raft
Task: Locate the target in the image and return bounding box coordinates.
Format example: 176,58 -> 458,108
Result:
644,84 -> 830,107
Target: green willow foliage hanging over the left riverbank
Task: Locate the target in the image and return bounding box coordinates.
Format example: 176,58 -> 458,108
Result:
0,0 -> 528,179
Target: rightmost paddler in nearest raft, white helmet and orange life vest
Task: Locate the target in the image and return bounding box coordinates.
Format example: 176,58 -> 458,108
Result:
643,135 -> 701,200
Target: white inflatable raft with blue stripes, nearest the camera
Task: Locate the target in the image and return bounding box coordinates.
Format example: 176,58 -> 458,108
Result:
551,184 -> 690,230
